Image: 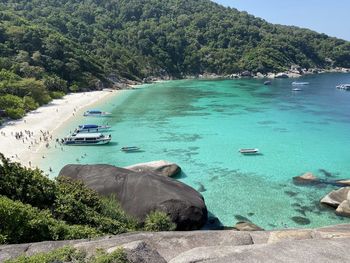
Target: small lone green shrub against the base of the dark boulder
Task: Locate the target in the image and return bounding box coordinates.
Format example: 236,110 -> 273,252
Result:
144,211 -> 176,231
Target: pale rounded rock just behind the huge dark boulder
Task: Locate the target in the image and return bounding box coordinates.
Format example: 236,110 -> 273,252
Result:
124,160 -> 181,177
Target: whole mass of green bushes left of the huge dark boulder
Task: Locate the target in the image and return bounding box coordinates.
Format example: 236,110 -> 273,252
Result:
0,154 -> 138,243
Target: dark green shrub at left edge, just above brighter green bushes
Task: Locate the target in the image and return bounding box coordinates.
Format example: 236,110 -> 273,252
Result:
0,153 -> 56,209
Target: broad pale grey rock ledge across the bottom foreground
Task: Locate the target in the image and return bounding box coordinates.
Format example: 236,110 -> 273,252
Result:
0,224 -> 350,263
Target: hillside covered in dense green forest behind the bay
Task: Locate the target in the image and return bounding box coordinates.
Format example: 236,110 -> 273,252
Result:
0,0 -> 350,118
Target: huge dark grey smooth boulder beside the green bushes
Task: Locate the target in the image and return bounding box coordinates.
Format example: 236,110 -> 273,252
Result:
59,164 -> 207,230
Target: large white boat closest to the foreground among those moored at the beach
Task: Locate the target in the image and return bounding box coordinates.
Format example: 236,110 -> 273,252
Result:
62,133 -> 112,145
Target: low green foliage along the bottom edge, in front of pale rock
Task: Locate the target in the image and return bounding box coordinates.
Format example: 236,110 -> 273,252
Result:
5,246 -> 129,263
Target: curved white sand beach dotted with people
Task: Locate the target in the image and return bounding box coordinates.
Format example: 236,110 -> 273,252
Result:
0,90 -> 118,167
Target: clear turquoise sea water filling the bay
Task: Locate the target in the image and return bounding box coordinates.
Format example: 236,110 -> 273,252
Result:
40,73 -> 350,229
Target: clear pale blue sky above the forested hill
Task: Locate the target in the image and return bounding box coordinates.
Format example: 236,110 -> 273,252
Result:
214,0 -> 350,41
